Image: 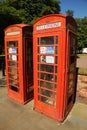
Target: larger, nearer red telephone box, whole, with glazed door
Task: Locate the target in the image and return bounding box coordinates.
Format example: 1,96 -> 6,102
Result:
33,14 -> 77,121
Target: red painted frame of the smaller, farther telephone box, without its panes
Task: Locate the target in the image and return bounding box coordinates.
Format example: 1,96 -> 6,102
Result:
4,24 -> 33,104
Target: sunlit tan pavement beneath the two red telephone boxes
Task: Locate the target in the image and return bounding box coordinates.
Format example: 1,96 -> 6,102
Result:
0,87 -> 87,130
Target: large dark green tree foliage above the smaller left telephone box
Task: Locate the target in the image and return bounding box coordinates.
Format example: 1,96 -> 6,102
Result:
0,0 -> 60,53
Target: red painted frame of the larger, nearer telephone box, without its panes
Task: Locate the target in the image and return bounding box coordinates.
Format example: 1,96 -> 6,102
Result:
33,14 -> 77,121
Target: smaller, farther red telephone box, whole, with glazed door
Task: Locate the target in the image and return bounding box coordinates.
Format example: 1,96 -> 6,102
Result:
5,24 -> 33,104
